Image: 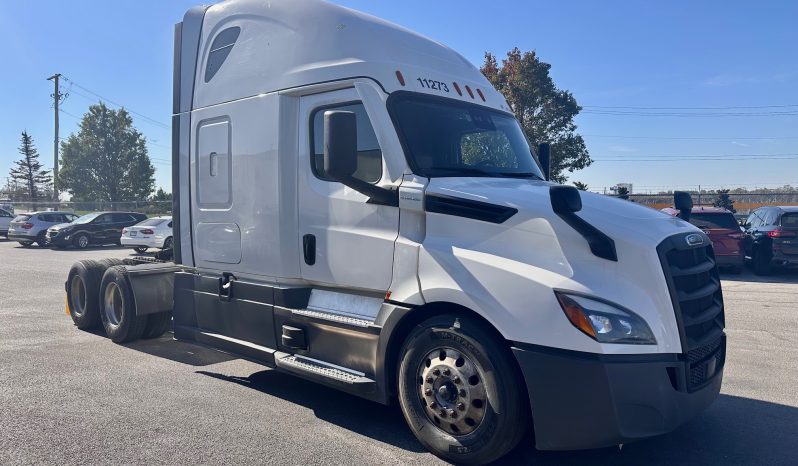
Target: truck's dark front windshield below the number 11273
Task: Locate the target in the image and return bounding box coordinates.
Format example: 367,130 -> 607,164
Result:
389,93 -> 543,179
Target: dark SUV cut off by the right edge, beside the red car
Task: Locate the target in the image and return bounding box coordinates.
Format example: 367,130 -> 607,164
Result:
744,206 -> 798,275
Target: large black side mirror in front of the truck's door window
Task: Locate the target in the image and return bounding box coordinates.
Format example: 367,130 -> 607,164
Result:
324,110 -> 357,180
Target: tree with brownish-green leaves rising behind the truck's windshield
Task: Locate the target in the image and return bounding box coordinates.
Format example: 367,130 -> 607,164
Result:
481,47 -> 593,183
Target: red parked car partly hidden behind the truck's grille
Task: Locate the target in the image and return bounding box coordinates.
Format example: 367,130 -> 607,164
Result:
662,206 -> 745,273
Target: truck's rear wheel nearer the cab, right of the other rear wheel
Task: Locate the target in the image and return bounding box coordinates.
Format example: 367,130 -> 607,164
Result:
99,266 -> 147,343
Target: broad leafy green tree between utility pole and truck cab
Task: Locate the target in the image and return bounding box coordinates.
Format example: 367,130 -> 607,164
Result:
58,102 -> 155,202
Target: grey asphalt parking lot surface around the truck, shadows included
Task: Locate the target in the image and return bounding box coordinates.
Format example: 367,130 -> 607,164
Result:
0,239 -> 798,465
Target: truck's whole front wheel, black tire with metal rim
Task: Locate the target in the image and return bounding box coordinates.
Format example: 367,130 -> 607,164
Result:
398,315 -> 530,464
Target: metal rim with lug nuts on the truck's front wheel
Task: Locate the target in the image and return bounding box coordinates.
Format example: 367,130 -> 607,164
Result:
418,348 -> 488,436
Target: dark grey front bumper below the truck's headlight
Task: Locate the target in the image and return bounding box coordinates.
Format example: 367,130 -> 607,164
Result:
513,339 -> 725,450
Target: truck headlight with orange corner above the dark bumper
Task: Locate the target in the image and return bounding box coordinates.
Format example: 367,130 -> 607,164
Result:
555,291 -> 657,345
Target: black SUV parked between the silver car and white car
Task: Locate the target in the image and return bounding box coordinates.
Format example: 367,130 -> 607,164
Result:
47,212 -> 147,249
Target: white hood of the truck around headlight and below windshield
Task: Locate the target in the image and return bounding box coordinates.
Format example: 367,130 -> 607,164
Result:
419,178 -> 709,352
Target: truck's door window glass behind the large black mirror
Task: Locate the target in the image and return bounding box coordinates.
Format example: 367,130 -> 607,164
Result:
310,102 -> 382,183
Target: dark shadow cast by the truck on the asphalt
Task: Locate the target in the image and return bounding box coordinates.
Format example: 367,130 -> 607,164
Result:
197,370 -> 798,466
